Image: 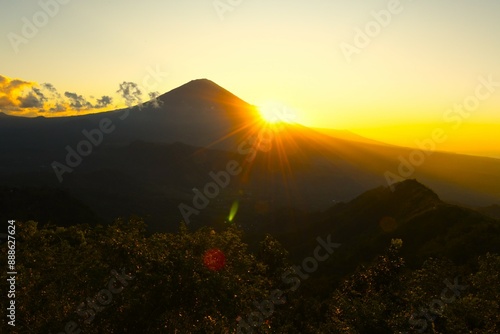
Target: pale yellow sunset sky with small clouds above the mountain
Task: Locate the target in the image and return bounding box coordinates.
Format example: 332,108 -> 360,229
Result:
0,0 -> 500,157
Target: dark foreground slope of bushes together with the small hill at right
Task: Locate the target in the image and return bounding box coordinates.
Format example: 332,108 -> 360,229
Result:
0,180 -> 500,334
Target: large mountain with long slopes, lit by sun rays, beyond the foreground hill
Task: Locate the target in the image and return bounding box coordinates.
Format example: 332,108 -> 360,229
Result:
0,79 -> 500,230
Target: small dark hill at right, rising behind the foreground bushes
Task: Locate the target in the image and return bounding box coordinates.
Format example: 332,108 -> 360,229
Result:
276,180 -> 500,277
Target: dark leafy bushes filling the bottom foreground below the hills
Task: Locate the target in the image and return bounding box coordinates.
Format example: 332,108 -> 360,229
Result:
1,219 -> 500,334
